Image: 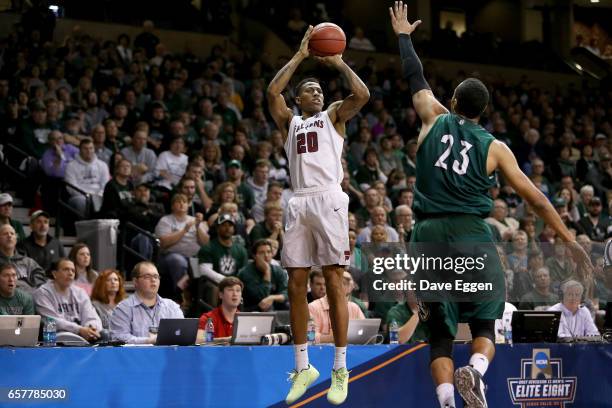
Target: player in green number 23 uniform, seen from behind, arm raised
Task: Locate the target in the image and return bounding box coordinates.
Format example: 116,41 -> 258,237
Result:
389,1 -> 592,408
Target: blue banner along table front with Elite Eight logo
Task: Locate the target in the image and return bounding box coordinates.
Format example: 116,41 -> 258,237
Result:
0,344 -> 612,408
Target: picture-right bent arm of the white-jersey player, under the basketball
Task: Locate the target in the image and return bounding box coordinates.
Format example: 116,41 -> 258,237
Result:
317,55 -> 370,125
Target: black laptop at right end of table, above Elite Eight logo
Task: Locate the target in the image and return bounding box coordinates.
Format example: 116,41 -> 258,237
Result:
512,310 -> 561,343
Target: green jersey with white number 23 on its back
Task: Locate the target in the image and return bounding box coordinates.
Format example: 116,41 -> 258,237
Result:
414,114 -> 495,216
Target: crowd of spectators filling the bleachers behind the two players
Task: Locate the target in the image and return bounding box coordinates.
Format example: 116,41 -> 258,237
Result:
0,9 -> 612,341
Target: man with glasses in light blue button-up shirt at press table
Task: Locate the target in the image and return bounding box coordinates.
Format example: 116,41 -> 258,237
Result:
110,261 -> 184,344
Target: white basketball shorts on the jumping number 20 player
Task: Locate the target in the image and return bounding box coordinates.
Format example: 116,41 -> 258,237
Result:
281,185 -> 351,268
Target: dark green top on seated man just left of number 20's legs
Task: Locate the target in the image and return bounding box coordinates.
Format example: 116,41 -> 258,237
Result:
238,262 -> 288,311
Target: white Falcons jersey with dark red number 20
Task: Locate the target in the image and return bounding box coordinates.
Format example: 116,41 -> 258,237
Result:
285,111 -> 344,190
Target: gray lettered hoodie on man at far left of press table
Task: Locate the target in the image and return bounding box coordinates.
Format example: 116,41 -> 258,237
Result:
34,280 -> 102,334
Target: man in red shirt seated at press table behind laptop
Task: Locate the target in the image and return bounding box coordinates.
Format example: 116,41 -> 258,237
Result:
197,276 -> 244,342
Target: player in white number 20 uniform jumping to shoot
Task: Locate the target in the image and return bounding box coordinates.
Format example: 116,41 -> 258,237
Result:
267,26 -> 370,405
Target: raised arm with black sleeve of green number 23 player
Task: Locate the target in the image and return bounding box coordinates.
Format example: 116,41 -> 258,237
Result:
389,1 -> 448,127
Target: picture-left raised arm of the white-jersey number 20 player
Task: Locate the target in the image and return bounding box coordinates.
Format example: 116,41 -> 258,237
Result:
267,26 -> 313,139
